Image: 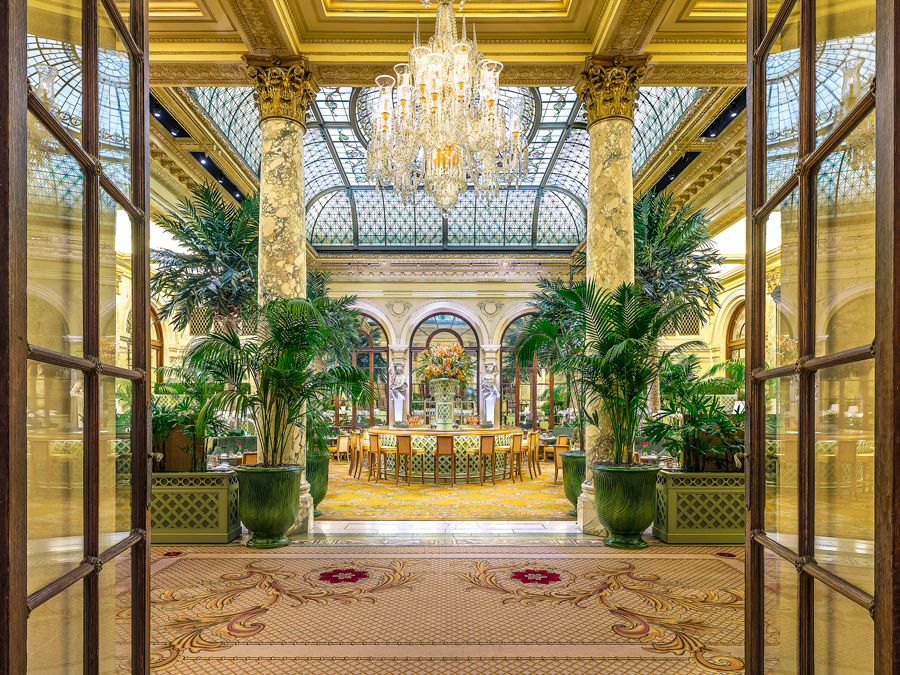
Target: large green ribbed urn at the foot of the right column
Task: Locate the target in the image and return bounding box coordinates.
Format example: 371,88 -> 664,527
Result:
591,464 -> 660,548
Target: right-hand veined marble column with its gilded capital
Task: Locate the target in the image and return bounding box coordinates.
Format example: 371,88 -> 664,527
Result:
576,56 -> 647,536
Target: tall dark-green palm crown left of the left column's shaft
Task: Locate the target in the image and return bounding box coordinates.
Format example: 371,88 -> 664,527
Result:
150,183 -> 259,330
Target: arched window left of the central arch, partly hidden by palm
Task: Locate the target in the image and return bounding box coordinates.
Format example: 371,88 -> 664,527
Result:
334,314 -> 388,429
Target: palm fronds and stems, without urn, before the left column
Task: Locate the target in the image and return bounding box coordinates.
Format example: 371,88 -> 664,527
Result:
185,299 -> 375,467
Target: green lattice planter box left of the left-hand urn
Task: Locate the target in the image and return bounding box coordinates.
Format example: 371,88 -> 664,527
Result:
150,471 -> 241,544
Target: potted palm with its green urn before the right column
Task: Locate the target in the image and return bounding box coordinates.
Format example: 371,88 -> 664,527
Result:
521,281 -> 698,548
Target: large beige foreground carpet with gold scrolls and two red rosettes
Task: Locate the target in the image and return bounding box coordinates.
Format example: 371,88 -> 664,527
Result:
139,538 -> 744,675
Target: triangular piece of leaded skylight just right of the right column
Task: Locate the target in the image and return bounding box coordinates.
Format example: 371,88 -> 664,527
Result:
631,87 -> 703,173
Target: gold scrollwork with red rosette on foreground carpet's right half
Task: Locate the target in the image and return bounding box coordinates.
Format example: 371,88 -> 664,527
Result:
456,561 -> 744,673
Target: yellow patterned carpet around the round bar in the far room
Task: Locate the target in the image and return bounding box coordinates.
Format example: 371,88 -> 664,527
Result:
316,462 -> 574,520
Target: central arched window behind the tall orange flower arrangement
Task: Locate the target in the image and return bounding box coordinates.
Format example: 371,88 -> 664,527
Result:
409,312 -> 481,417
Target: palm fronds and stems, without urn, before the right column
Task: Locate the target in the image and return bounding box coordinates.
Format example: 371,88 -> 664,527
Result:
516,281 -> 697,464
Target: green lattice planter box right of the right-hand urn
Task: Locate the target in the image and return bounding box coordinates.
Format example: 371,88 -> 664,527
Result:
653,470 -> 744,544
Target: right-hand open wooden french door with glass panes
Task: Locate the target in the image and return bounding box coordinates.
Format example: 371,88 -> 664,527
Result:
746,0 -> 900,675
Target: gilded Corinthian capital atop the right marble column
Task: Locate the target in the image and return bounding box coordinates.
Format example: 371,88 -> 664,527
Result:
575,56 -> 649,126
